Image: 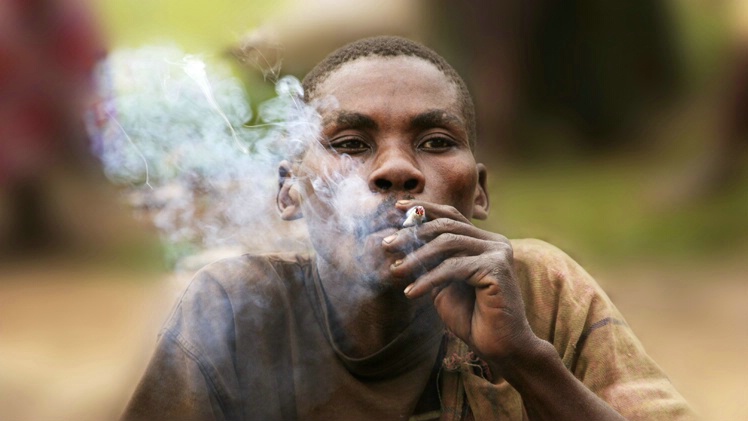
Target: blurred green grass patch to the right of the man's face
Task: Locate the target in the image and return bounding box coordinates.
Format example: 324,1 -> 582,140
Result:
482,160 -> 748,265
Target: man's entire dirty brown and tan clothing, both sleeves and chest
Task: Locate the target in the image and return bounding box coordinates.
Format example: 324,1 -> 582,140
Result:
123,240 -> 693,421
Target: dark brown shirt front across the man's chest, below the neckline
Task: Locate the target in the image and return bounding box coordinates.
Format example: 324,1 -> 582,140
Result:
237,306 -> 439,421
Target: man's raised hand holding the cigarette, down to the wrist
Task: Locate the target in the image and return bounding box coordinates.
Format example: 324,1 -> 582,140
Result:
383,201 -> 538,374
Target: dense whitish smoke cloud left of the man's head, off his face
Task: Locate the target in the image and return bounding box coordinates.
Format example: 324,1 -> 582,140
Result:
88,46 -> 319,266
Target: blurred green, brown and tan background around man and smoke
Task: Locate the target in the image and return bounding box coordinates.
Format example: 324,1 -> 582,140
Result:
0,0 -> 748,421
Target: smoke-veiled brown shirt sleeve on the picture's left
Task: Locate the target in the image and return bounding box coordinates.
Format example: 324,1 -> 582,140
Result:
121,267 -> 239,421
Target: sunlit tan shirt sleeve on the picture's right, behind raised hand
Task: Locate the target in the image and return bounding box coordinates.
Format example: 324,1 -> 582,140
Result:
515,240 -> 695,421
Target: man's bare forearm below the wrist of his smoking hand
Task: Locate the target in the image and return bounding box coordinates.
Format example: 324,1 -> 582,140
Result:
489,338 -> 625,421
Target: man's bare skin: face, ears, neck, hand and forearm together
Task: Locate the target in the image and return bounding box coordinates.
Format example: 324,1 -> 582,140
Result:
278,57 -> 623,420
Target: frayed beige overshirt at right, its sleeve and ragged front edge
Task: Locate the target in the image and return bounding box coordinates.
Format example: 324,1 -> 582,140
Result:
442,240 -> 695,421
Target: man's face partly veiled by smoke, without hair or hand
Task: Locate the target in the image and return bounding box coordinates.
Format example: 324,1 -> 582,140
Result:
284,57 -> 485,283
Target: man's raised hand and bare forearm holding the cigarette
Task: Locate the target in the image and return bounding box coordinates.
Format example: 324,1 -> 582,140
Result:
383,202 -> 624,420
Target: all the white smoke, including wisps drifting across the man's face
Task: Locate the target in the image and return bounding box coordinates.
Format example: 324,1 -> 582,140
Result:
88,47 -> 442,398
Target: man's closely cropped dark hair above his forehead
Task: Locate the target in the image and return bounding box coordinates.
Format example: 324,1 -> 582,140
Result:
301,35 -> 476,150
